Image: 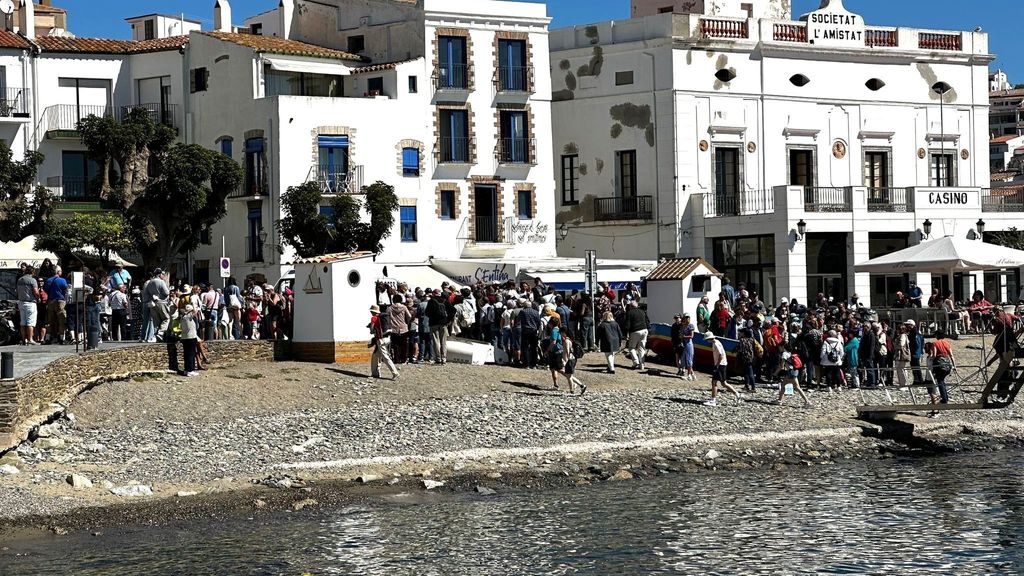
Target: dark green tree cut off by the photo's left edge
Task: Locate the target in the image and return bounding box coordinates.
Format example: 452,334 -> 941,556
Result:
0,142 -> 53,242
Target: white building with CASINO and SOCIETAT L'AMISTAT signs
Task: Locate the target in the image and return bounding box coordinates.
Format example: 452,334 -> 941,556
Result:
551,0 -> 1022,305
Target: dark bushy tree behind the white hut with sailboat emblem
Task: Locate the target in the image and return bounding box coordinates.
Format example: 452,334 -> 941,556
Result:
278,180 -> 398,257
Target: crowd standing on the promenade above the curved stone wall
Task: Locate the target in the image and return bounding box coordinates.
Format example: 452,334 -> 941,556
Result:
9,259 -> 295,354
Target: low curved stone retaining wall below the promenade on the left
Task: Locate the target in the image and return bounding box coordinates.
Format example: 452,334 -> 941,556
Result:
0,340 -> 281,452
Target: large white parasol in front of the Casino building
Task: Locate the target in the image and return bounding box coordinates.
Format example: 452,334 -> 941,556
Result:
853,236 -> 1024,275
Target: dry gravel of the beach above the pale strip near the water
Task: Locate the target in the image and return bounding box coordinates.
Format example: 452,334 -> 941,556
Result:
0,334 -> 1016,520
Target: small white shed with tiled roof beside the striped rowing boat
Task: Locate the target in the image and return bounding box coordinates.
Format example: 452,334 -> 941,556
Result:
646,258 -> 722,324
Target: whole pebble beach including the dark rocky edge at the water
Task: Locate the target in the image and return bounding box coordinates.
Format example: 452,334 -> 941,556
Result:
0,358 -> 1024,533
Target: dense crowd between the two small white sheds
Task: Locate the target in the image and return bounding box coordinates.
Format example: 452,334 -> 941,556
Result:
368,278 -> 650,393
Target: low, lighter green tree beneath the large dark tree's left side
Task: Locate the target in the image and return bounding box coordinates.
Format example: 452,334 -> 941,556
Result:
36,212 -> 133,269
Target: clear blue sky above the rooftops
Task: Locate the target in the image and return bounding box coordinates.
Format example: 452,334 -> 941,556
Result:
54,0 -> 1024,83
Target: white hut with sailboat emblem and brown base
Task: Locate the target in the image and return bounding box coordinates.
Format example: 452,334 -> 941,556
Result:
292,252 -> 384,363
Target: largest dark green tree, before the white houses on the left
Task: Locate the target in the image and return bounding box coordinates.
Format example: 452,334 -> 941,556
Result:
79,109 -> 243,268
